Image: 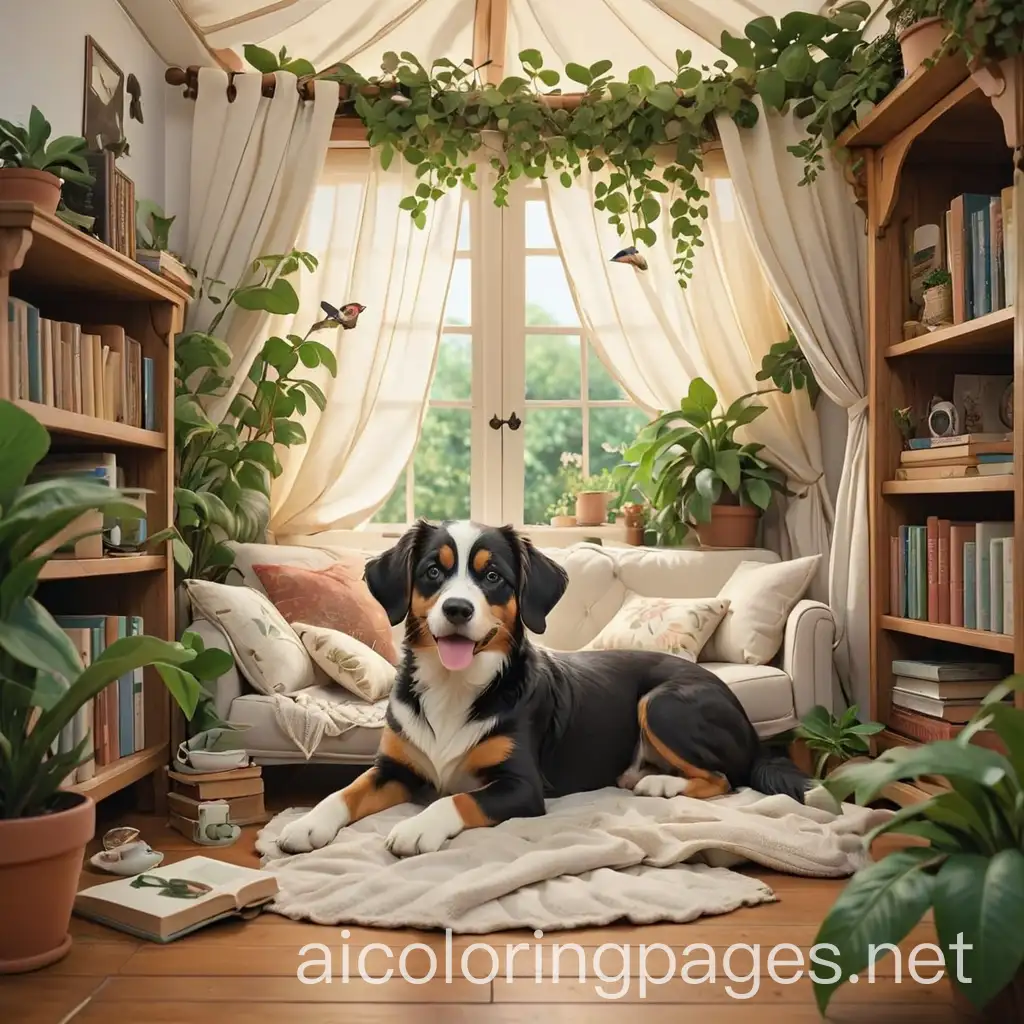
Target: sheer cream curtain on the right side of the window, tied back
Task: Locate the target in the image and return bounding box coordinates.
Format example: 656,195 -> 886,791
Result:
548,154 -> 833,599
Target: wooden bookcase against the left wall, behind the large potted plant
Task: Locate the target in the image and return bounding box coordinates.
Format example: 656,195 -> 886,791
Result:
0,203 -> 187,806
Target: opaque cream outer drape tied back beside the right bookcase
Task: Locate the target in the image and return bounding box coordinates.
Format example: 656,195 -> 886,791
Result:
718,99 -> 869,708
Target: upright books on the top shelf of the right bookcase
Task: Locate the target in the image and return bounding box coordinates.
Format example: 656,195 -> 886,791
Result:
945,188 -> 1017,324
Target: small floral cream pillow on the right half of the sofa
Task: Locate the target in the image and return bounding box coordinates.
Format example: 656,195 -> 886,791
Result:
583,591 -> 729,662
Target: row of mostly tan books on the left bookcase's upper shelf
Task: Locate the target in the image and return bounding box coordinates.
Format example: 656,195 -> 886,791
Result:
0,299 -> 156,430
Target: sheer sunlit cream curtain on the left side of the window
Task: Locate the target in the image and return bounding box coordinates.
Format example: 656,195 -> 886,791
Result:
270,150 -> 460,541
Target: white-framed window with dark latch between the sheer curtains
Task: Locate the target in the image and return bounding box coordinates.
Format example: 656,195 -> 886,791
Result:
373,181 -> 647,524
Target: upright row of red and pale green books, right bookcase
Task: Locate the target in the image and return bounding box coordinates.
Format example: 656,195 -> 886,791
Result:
889,516 -> 1014,636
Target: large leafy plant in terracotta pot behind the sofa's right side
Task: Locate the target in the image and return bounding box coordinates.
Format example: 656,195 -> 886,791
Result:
612,377 -> 794,548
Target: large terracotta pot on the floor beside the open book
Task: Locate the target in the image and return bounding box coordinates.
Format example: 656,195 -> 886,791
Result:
0,794 -> 96,974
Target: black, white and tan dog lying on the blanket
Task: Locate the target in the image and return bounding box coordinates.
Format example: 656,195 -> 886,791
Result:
278,521 -> 812,856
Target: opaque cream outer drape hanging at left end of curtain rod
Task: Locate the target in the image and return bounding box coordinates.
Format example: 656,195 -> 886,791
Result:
185,68 -> 338,417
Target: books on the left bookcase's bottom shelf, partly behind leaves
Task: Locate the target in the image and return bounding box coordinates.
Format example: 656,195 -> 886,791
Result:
55,615 -> 145,784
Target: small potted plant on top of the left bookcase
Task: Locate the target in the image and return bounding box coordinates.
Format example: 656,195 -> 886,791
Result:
0,106 -> 94,213
